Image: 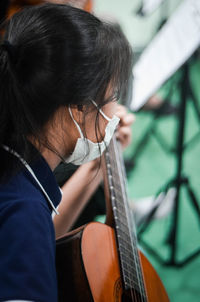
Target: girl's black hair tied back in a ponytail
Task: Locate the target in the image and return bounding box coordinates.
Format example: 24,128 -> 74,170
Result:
0,4 -> 132,178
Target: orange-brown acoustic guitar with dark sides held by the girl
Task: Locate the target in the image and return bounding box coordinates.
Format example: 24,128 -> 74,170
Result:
56,138 -> 169,302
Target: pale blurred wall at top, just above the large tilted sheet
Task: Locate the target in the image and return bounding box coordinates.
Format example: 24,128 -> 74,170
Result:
94,0 -> 184,49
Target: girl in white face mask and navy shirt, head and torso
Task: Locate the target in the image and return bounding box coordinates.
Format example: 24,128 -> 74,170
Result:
0,4 -> 131,302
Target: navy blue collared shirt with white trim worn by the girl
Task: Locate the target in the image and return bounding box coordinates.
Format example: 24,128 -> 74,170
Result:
0,158 -> 61,302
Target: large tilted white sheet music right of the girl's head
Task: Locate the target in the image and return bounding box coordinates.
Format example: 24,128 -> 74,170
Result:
130,0 -> 200,111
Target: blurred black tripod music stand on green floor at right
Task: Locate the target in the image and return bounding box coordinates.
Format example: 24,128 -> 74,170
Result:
138,62 -> 200,267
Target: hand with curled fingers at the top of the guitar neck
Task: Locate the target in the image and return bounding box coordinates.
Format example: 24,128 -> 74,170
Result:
116,105 -> 135,149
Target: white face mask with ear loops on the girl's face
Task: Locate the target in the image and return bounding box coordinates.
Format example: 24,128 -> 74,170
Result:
65,101 -> 120,165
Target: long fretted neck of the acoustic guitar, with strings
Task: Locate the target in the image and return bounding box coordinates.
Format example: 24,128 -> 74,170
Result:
105,137 -> 146,301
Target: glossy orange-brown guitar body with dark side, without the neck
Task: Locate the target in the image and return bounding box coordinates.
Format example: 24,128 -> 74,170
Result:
56,222 -> 169,302
